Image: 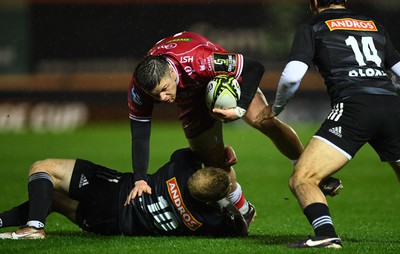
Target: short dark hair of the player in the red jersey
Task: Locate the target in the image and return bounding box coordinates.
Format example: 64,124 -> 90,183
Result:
134,55 -> 169,92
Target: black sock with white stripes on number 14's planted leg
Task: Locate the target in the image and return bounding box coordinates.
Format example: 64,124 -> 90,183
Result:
303,203 -> 337,237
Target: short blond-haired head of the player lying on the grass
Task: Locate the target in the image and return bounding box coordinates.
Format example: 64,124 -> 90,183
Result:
188,167 -> 231,202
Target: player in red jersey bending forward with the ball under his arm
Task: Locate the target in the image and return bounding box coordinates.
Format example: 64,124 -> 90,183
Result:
128,32 -> 342,222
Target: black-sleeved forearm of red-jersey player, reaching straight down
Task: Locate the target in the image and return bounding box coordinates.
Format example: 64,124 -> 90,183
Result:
131,120 -> 151,181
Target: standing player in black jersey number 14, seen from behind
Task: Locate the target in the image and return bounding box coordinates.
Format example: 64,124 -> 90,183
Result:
272,0 -> 400,248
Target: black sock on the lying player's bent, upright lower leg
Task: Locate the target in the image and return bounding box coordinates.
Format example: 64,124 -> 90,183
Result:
26,172 -> 54,228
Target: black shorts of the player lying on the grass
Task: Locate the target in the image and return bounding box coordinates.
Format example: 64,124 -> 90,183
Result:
69,159 -> 122,235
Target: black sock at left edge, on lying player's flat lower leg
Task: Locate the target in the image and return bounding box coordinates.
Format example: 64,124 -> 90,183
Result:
0,201 -> 29,228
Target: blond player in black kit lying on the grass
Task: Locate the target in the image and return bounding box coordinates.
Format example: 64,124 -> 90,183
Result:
0,146 -> 248,239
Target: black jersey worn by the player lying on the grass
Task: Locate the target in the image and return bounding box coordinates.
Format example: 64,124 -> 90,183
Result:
119,149 -> 240,236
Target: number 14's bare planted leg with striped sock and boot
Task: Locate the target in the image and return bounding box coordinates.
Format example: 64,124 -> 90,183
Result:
288,138 -> 349,248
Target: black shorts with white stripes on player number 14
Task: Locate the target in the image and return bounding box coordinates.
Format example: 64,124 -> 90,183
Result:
315,94 -> 400,162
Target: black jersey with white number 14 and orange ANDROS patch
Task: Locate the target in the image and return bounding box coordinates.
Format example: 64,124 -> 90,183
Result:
289,9 -> 400,104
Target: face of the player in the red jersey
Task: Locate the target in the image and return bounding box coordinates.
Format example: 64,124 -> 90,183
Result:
150,69 -> 177,103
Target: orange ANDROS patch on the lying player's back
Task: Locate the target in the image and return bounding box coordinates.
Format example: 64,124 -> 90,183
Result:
167,177 -> 202,231
